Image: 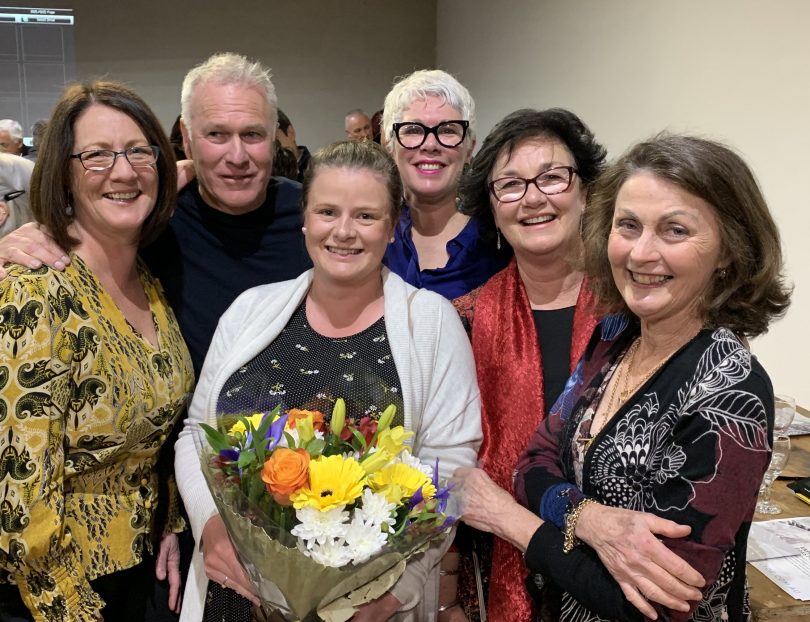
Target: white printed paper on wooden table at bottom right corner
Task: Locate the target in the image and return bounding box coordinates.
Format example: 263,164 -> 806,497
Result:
748,517 -> 810,600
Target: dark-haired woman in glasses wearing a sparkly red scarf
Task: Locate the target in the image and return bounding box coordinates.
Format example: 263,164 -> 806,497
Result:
454,108 -> 605,620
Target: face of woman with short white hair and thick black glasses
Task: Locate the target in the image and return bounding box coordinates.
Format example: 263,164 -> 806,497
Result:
391,96 -> 475,205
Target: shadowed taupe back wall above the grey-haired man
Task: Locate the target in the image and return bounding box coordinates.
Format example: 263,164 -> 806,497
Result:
15,0 -> 436,148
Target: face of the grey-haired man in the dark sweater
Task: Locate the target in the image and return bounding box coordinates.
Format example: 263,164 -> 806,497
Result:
181,82 -> 276,214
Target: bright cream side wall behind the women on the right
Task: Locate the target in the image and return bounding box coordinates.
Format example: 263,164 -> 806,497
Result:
437,0 -> 810,407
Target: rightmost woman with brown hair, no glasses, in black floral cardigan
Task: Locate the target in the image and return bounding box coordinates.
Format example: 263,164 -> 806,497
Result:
461,136 -> 790,622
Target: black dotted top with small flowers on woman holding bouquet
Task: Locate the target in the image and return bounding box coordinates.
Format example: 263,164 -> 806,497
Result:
217,302 -> 404,425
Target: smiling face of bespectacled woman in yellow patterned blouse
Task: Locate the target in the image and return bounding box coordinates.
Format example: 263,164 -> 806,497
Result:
70,104 -> 158,245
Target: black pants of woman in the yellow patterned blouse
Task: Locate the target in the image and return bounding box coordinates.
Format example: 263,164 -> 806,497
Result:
0,557 -> 155,622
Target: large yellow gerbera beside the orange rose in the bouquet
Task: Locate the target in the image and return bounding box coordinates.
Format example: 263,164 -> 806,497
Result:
290,456 -> 366,512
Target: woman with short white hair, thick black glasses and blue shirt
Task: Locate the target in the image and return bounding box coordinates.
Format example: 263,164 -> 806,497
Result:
382,70 -> 510,299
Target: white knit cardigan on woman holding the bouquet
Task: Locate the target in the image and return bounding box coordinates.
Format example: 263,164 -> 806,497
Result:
175,268 -> 481,622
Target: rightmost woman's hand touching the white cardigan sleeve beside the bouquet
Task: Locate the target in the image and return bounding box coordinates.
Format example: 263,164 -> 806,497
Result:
452,467 -> 543,551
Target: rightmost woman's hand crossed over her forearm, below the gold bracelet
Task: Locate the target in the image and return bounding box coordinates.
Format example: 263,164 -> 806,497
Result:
576,503 -> 705,618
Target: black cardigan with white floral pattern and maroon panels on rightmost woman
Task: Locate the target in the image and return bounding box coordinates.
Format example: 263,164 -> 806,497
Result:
515,316 -> 774,622
